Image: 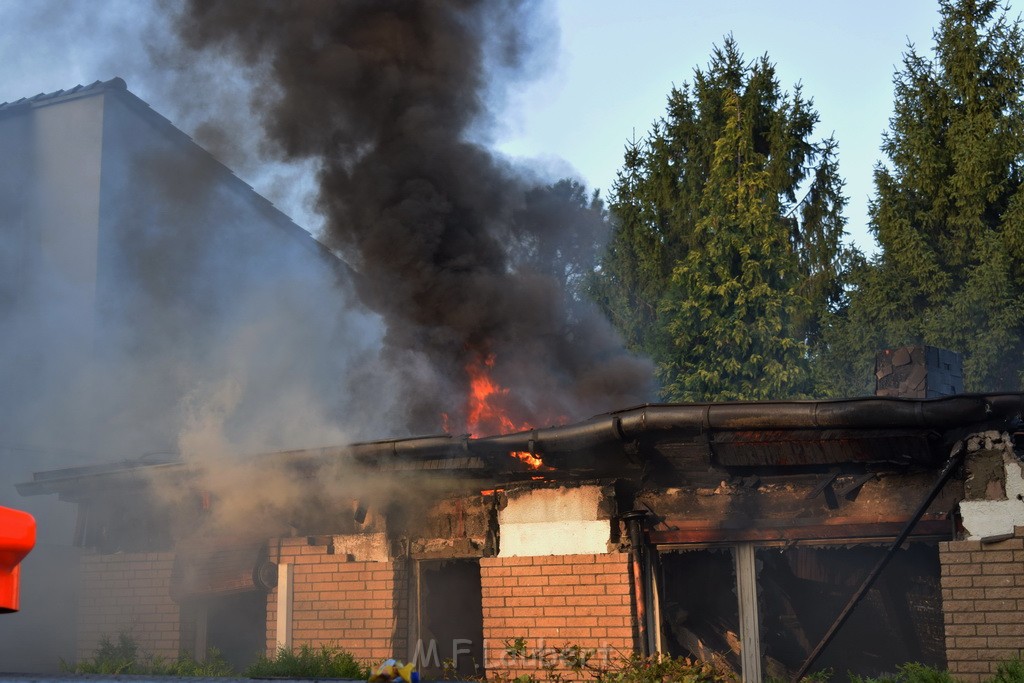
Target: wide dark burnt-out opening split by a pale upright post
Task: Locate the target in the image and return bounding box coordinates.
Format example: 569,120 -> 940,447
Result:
660,543 -> 946,680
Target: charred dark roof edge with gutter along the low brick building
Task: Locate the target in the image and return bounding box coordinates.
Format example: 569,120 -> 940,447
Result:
16,393 -> 1024,496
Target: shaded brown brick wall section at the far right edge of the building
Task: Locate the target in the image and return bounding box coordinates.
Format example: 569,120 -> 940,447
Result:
939,526 -> 1024,681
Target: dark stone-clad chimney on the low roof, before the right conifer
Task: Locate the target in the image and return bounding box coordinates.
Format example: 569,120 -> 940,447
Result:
874,345 -> 964,398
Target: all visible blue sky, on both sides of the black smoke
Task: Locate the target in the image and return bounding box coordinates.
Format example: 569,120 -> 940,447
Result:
0,0 -> 1024,253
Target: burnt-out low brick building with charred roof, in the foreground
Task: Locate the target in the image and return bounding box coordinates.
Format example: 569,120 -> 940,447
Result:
18,376 -> 1024,680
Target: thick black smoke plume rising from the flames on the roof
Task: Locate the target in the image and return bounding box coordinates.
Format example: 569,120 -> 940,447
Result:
166,0 -> 651,432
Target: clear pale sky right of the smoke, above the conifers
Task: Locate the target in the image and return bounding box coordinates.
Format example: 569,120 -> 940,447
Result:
491,0 -> 1011,252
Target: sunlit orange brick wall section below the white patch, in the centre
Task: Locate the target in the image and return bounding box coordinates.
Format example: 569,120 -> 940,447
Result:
480,553 -> 634,676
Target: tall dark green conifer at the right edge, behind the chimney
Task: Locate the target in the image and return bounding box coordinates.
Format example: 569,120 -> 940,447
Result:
822,0 -> 1024,393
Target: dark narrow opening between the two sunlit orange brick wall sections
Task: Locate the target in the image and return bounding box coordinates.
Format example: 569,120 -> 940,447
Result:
414,559 -> 483,677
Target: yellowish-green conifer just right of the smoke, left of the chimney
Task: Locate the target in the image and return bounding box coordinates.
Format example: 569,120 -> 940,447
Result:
592,36 -> 852,400
